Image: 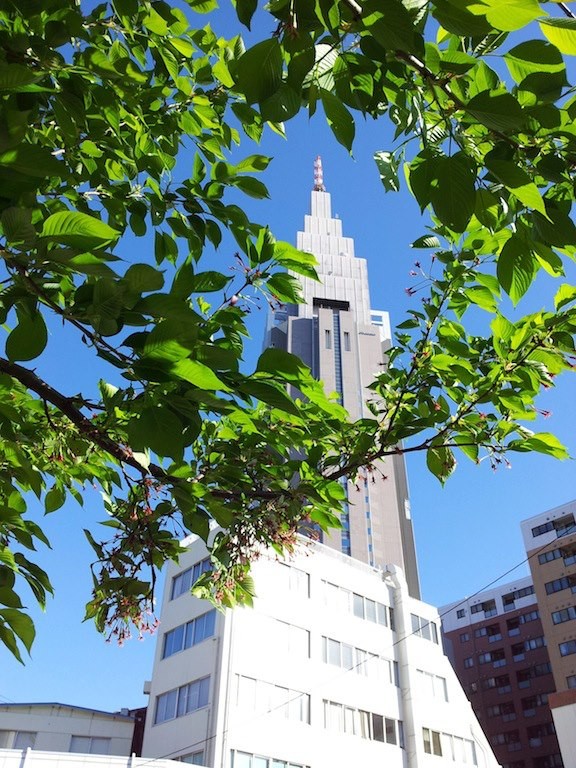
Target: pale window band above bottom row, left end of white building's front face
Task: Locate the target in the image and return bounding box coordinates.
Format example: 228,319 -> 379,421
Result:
236,675 -> 310,723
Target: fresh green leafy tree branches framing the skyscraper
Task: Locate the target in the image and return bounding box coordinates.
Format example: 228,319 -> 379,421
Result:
0,0 -> 576,659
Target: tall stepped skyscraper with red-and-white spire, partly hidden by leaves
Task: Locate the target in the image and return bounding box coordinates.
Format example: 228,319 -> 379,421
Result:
266,157 -> 420,597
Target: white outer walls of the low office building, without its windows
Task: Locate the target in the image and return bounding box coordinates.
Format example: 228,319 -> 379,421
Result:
143,542 -> 497,768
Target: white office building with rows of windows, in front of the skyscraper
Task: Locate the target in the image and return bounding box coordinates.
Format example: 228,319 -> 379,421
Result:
143,539 -> 498,768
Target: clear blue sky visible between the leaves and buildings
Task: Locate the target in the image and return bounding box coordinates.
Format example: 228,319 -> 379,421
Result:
0,9 -> 576,710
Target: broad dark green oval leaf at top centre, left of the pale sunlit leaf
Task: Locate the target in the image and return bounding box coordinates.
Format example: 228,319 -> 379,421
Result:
234,38 -> 282,104
